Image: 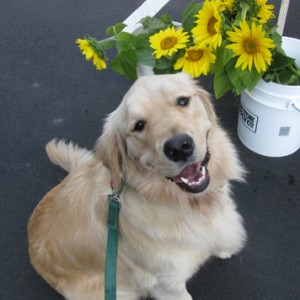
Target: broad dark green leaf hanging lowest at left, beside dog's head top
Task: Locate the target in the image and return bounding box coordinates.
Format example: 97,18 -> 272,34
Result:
110,50 -> 137,80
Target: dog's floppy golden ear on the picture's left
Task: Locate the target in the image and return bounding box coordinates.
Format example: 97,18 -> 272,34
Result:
94,112 -> 124,189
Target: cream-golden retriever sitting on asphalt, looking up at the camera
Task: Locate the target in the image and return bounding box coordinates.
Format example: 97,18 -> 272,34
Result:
28,74 -> 246,300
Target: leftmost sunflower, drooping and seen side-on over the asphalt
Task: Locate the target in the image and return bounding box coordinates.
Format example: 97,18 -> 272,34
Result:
76,38 -> 106,71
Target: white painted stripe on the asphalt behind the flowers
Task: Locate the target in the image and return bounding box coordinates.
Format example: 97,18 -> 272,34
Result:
123,0 -> 170,33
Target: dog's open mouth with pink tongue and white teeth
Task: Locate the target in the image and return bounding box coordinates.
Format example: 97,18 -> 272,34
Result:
173,152 -> 210,193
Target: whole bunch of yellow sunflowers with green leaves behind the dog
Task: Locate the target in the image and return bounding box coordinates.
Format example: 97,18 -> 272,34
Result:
77,0 -> 300,98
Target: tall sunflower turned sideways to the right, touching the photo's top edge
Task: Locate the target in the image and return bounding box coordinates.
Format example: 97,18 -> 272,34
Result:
192,1 -> 223,49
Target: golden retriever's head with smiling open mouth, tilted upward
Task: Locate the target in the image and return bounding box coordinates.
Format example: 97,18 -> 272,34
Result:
96,73 -> 239,193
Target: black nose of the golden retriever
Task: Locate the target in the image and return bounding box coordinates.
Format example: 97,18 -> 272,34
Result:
164,133 -> 195,162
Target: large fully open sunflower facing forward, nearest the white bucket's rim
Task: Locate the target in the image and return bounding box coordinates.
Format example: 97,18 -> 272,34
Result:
226,20 -> 275,73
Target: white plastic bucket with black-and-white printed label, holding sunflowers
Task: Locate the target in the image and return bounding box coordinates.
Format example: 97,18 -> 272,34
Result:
238,37 -> 300,157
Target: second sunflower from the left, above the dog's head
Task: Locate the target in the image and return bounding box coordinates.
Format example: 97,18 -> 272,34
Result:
149,27 -> 189,59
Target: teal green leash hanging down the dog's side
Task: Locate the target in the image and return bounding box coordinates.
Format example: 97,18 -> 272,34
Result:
105,182 -> 126,300
